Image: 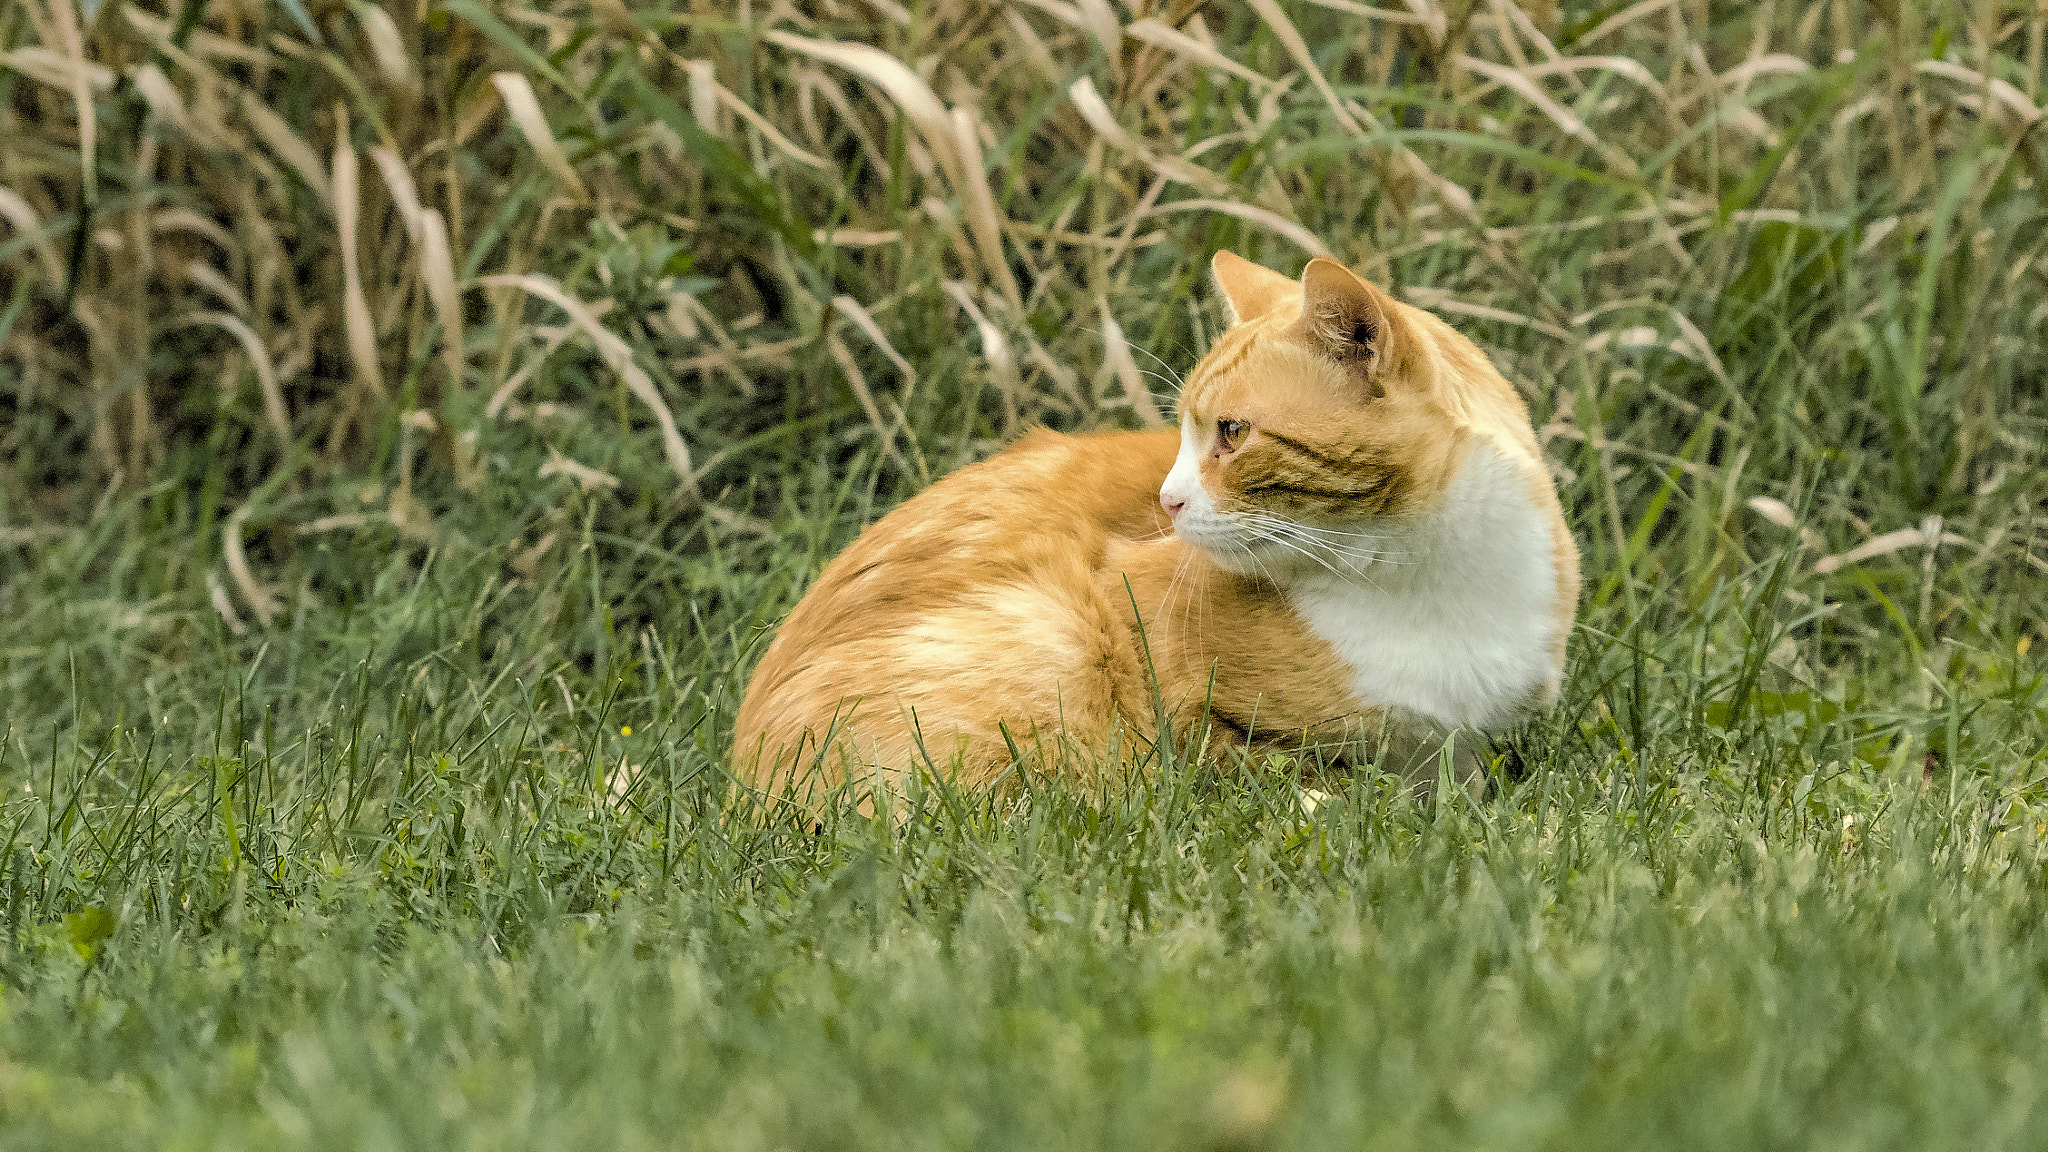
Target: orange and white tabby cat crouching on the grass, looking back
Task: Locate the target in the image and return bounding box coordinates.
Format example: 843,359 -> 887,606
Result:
733,252 -> 1579,789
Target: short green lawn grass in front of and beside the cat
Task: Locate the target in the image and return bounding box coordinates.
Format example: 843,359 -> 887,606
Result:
0,553 -> 2048,1148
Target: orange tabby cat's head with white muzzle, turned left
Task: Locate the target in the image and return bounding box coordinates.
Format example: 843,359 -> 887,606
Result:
1159,252 -> 1477,578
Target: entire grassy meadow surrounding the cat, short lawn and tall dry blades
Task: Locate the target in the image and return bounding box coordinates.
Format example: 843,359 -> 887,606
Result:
0,0 -> 2048,1152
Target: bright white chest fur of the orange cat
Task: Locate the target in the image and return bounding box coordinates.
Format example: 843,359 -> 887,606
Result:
1290,443 -> 1561,728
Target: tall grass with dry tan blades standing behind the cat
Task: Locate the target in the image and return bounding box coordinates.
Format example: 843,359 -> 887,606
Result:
0,0 -> 2048,664
